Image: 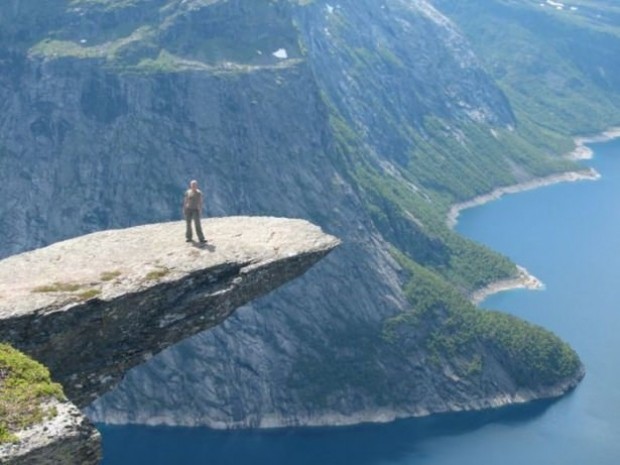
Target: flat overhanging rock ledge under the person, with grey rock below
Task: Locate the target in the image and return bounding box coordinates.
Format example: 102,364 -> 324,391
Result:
0,217 -> 339,463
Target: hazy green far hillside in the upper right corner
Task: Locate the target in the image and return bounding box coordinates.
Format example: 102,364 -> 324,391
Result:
442,0 -> 620,136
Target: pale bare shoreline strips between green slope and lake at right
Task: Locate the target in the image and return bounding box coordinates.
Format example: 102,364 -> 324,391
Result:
446,126 -> 620,305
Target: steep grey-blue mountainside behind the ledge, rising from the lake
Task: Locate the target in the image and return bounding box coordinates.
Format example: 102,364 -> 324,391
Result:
0,0 -> 620,427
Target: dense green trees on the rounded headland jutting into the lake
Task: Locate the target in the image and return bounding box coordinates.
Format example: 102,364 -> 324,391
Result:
383,252 -> 581,388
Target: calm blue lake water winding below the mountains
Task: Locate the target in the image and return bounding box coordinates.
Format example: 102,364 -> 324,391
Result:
101,141 -> 620,465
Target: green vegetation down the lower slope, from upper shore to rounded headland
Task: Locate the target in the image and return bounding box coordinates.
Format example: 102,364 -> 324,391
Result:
310,40 -> 581,398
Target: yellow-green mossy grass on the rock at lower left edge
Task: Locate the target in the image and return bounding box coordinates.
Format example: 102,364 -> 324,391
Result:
0,344 -> 64,444
